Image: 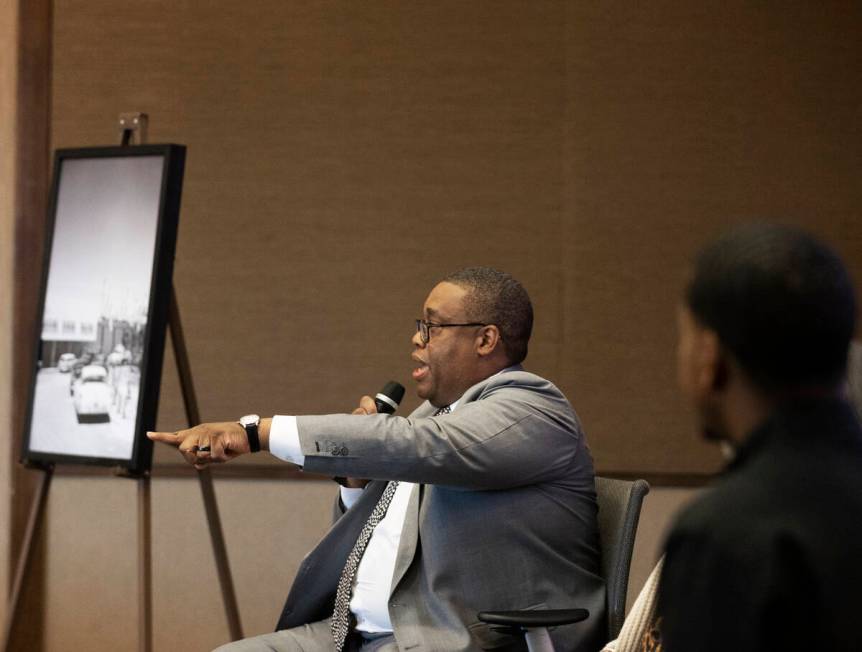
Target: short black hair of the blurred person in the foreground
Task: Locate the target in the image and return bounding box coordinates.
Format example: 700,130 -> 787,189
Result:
686,223 -> 856,391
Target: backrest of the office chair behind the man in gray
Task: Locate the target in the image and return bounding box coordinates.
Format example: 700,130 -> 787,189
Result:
596,477 -> 649,641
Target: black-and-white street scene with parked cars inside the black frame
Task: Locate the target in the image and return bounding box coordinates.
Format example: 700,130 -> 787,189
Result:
28,156 -> 162,460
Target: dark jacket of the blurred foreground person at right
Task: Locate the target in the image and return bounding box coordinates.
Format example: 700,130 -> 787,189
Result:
658,400 -> 862,652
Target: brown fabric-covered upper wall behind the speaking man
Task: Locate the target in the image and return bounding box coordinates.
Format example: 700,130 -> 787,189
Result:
53,0 -> 862,472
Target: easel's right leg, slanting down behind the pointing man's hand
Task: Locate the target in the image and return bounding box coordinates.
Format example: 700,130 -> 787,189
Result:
168,287 -> 242,641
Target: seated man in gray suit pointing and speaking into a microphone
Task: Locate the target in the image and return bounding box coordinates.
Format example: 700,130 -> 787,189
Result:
150,268 -> 605,652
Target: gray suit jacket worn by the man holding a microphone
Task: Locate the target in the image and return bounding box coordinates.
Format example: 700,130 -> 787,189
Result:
278,370 -> 605,652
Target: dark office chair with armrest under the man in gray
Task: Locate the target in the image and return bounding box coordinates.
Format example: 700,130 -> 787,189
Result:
478,477 -> 649,652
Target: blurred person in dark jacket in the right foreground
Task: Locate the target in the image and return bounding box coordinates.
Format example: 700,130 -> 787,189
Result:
658,224 -> 862,652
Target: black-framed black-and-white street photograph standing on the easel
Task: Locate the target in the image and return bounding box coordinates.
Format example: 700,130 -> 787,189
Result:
21,145 -> 185,473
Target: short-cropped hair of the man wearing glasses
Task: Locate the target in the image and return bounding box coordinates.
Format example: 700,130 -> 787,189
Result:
441,267 -> 533,364
